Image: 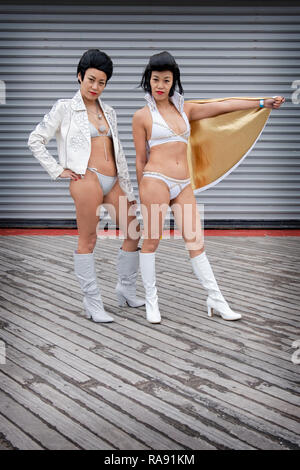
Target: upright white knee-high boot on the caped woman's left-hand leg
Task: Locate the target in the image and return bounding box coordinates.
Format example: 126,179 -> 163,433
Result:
140,252 -> 161,323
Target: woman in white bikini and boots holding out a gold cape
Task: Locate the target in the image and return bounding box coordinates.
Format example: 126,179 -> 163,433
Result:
132,52 -> 284,323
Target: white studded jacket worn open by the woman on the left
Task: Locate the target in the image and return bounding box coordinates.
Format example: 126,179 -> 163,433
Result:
28,91 -> 135,201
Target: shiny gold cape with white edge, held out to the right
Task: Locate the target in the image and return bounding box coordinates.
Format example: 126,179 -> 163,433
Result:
187,97 -> 272,192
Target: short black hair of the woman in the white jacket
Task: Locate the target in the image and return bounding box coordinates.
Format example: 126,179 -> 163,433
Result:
77,49 -> 113,83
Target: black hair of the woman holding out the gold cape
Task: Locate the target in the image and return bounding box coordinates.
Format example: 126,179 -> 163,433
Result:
140,51 -> 183,96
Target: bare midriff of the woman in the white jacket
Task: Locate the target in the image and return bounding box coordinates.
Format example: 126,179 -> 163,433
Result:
88,136 -> 117,176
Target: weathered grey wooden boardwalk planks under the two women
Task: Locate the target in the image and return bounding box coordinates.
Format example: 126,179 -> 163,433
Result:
0,236 -> 300,450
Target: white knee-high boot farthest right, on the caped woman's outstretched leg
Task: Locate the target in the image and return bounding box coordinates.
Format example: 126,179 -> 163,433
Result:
191,252 -> 242,320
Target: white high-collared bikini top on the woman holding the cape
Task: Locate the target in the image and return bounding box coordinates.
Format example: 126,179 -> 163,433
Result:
145,91 -> 191,148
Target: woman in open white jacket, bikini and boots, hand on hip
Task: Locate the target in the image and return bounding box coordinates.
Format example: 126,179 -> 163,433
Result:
28,49 -> 145,322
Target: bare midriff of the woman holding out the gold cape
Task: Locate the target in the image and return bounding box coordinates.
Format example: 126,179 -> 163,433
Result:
144,142 -> 190,179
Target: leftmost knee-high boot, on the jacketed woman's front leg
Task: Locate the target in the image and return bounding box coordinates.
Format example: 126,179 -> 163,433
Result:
74,251 -> 114,323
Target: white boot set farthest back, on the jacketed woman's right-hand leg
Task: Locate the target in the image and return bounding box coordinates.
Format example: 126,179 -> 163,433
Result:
116,248 -> 145,307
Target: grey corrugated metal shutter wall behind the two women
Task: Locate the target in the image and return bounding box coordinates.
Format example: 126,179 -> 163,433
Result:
0,2 -> 300,226
